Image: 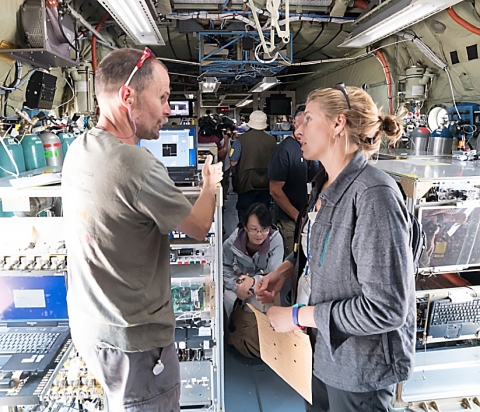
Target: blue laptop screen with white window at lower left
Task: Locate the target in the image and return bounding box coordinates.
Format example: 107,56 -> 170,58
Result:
0,275 -> 68,322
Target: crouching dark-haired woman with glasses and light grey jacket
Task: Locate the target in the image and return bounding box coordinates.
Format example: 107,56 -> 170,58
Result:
223,203 -> 283,357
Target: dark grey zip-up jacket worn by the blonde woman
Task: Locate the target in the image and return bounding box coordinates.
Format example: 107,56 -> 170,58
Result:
289,153 -> 416,392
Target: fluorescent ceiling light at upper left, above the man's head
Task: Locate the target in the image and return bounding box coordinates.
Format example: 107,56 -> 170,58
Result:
98,0 -> 165,46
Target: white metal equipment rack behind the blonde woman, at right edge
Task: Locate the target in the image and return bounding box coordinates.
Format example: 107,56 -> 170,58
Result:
374,156 -> 480,412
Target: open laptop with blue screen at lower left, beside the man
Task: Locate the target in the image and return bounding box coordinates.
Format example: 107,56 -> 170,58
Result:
0,272 -> 70,372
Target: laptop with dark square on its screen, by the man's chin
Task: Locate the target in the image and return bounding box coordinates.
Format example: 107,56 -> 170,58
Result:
140,126 -> 198,184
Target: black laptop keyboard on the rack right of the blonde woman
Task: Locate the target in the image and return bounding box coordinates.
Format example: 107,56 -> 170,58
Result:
427,297 -> 480,339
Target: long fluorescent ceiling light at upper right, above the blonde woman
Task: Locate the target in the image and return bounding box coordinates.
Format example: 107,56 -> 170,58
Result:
338,0 -> 462,48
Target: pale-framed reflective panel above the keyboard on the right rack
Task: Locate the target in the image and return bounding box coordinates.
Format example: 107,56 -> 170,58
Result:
418,205 -> 480,272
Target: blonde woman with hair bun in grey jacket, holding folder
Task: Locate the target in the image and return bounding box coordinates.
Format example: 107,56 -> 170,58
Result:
255,83 -> 415,412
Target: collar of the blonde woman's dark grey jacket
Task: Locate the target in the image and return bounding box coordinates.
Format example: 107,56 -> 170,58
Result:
313,152 -> 367,205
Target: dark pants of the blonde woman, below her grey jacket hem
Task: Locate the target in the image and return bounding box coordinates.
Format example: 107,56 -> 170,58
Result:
305,376 -> 394,412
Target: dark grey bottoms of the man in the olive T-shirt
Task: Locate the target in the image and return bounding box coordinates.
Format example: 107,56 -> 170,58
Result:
74,339 -> 180,412
